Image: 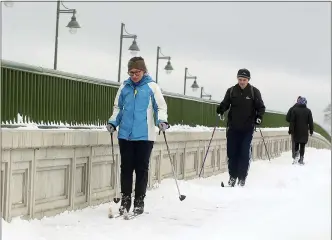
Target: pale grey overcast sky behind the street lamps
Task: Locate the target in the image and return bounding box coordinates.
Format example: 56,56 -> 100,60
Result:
2,1 -> 331,131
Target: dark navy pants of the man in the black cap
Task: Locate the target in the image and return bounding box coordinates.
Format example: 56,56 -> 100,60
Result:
227,128 -> 254,180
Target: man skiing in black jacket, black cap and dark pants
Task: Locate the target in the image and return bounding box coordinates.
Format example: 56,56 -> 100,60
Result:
217,69 -> 265,187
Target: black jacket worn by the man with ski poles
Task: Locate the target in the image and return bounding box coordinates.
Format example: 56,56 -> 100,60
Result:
218,84 -> 265,130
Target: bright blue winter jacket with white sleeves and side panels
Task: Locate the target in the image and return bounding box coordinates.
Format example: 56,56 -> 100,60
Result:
108,74 -> 167,141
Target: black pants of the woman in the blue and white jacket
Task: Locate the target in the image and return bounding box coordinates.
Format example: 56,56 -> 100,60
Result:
119,139 -> 154,198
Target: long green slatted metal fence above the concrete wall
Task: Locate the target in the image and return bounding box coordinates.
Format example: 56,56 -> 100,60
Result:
1,61 -> 331,140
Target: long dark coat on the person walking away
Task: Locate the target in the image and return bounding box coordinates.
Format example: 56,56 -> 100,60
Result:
289,104 -> 314,143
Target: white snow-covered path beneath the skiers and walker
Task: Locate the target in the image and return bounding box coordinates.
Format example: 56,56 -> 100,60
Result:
2,148 -> 331,240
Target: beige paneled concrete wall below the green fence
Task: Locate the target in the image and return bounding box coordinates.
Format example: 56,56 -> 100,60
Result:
0,129 -> 331,221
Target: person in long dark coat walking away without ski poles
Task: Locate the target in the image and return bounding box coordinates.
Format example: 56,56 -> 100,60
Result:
288,97 -> 314,165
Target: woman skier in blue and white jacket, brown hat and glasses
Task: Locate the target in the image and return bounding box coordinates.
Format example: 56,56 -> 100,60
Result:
107,57 -> 169,215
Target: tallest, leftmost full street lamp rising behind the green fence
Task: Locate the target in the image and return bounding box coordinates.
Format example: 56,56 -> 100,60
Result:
54,0 -> 80,70
